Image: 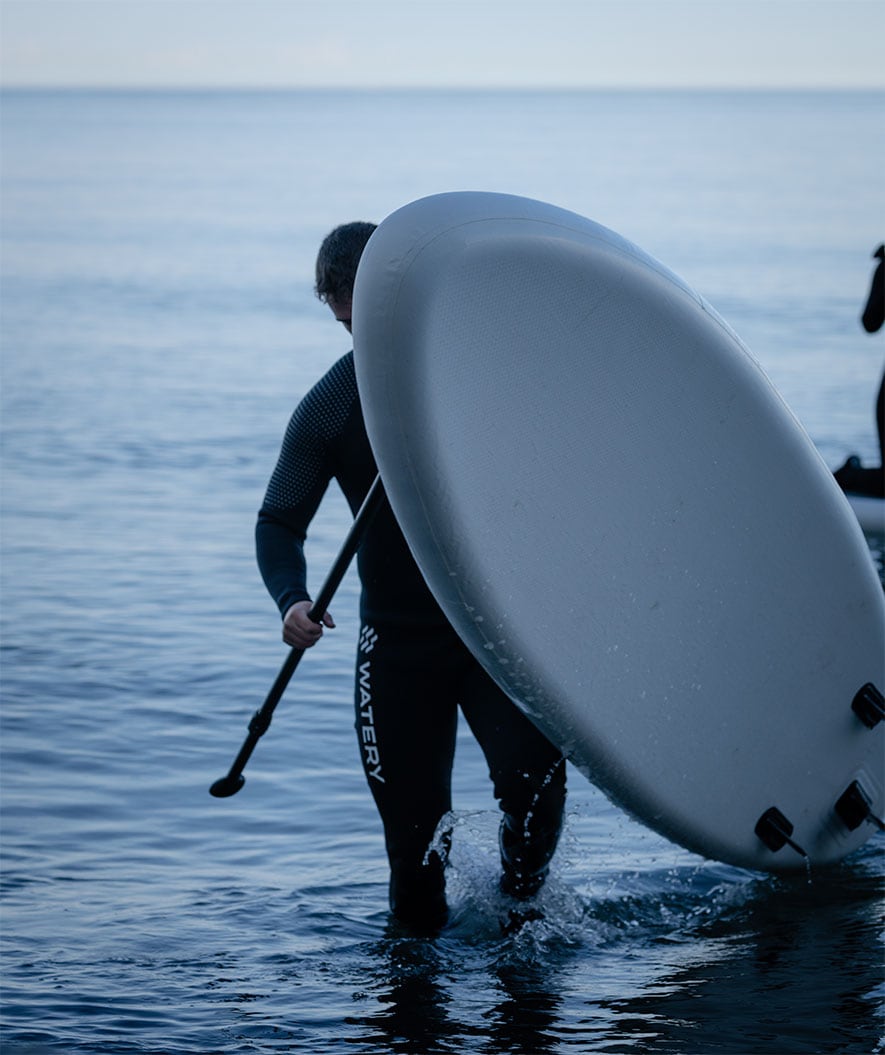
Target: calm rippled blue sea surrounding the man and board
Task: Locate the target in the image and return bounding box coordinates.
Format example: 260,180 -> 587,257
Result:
0,93 -> 885,1055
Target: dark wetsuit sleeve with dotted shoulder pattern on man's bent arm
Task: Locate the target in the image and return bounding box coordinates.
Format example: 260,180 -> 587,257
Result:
255,357 -> 355,615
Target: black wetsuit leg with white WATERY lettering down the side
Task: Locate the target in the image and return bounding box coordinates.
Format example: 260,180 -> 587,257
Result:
355,624 -> 458,931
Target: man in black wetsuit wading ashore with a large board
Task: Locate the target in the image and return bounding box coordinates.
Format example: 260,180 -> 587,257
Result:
255,223 -> 565,933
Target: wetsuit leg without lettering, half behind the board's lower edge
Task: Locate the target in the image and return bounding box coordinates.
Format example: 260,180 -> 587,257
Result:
461,660 -> 565,900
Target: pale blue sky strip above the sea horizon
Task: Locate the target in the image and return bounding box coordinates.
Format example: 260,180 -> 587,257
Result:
0,0 -> 885,88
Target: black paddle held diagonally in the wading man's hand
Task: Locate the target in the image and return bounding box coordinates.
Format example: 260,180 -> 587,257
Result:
209,476 -> 384,799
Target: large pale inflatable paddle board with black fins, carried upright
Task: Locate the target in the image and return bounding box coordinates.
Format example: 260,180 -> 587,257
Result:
353,193 -> 885,871
